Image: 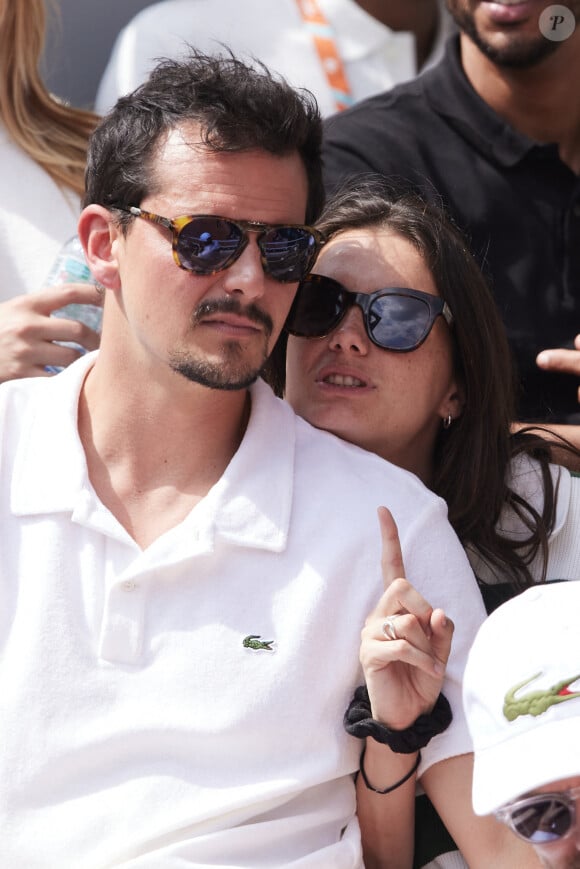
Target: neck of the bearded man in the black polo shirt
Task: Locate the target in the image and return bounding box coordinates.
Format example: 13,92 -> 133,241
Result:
460,29 -> 580,174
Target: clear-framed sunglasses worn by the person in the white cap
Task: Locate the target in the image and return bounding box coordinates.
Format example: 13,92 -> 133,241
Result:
496,787 -> 580,845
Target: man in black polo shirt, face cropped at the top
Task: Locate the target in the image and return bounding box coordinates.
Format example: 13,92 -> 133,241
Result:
324,0 -> 580,430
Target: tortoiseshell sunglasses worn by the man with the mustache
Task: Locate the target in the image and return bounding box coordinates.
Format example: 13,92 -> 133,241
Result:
119,205 -> 323,283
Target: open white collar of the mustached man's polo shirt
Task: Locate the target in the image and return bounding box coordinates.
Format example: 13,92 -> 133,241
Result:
11,352 -> 296,555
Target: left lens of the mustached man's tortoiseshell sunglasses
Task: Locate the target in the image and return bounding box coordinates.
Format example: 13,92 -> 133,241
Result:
177,217 -> 242,275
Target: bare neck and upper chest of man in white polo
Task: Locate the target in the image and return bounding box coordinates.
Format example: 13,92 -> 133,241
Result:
79,359 -> 250,548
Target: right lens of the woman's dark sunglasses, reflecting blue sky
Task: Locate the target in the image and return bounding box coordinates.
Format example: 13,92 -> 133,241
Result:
368,295 -> 430,350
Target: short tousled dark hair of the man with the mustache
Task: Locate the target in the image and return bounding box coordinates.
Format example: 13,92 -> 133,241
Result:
84,49 -> 324,222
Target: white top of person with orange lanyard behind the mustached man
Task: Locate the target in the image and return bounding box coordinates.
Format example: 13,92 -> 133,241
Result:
95,0 -> 424,116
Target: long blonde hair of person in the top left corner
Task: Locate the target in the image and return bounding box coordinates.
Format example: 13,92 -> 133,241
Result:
0,0 -> 98,196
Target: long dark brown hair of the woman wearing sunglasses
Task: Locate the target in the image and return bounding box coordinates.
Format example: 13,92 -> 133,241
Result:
265,175 -> 572,591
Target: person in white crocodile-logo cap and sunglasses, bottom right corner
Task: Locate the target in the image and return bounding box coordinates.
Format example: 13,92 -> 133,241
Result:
464,581 -> 580,869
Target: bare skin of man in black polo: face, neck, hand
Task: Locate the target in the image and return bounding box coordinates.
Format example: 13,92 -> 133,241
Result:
447,0 -> 580,440
